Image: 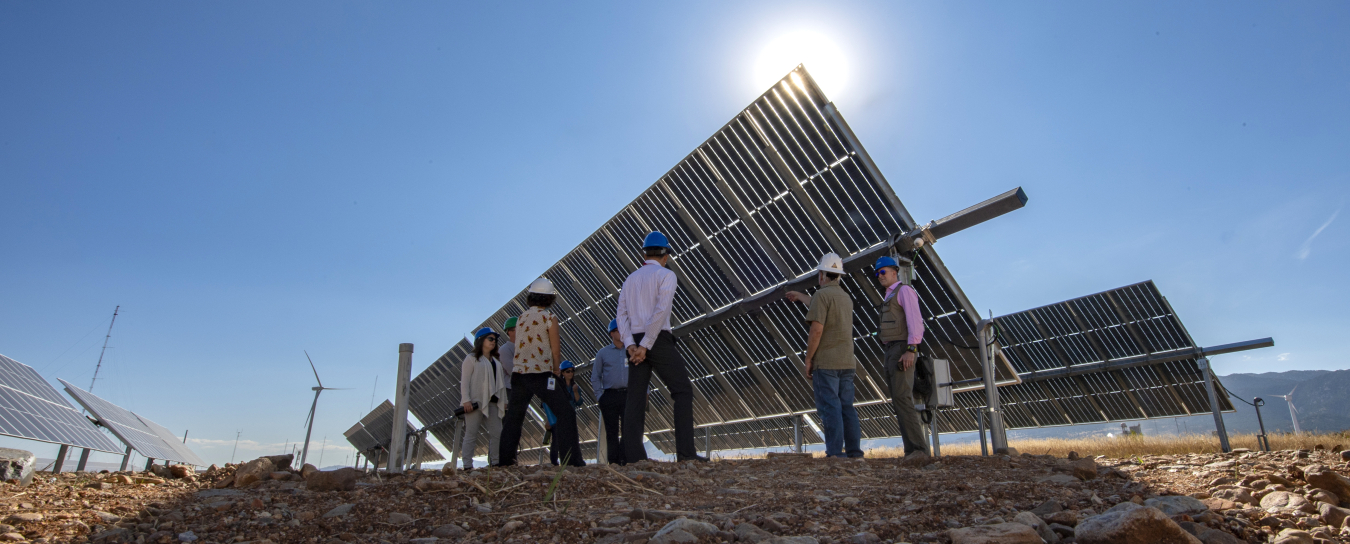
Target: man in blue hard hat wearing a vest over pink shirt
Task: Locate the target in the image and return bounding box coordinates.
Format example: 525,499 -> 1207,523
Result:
873,255 -> 929,463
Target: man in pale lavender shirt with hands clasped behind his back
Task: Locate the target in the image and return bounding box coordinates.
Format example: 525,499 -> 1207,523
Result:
614,231 -> 707,463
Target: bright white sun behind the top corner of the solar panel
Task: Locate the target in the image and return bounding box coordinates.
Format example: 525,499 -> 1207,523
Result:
755,30 -> 848,97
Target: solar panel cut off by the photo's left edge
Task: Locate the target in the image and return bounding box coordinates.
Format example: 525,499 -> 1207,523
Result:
0,355 -> 122,454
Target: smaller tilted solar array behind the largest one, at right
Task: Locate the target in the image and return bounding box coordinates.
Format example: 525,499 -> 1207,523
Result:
680,281 -> 1233,450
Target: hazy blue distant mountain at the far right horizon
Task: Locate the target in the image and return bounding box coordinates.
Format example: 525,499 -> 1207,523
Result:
1219,370 -> 1350,432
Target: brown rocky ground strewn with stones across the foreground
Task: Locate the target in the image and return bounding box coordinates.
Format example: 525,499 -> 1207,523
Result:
0,450 -> 1350,544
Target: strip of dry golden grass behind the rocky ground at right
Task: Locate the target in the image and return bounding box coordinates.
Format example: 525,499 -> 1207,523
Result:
867,431 -> 1350,458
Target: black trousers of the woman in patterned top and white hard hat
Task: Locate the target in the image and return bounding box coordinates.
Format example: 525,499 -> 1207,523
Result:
498,373 -> 586,467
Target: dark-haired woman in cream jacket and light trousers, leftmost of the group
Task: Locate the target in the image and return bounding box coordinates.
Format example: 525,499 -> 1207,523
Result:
459,327 -> 508,470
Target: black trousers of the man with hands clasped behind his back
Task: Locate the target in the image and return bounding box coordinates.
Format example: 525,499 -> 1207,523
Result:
624,331 -> 698,463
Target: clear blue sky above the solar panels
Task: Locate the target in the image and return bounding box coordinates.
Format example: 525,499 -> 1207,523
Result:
0,1 -> 1350,464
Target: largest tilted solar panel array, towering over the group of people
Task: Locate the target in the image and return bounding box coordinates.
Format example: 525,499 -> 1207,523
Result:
417,67 -> 1017,458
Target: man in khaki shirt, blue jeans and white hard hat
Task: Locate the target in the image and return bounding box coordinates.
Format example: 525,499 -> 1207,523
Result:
786,254 -> 863,458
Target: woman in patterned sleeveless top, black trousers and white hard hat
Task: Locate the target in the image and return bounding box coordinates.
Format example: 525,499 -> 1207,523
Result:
501,278 -> 586,467
